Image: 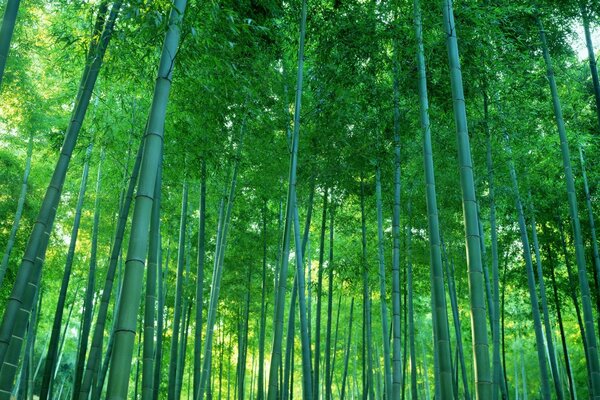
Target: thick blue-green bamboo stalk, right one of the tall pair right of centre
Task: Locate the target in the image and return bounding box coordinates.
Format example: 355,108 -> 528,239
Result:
443,0 -> 492,400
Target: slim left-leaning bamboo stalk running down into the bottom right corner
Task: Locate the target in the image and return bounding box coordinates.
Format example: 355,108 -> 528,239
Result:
536,15 -> 600,400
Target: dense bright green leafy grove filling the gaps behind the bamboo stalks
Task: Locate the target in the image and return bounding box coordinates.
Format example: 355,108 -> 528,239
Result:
0,0 -> 600,399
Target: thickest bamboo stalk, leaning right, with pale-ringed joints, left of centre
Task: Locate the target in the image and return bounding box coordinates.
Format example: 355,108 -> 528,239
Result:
107,0 -> 187,400
